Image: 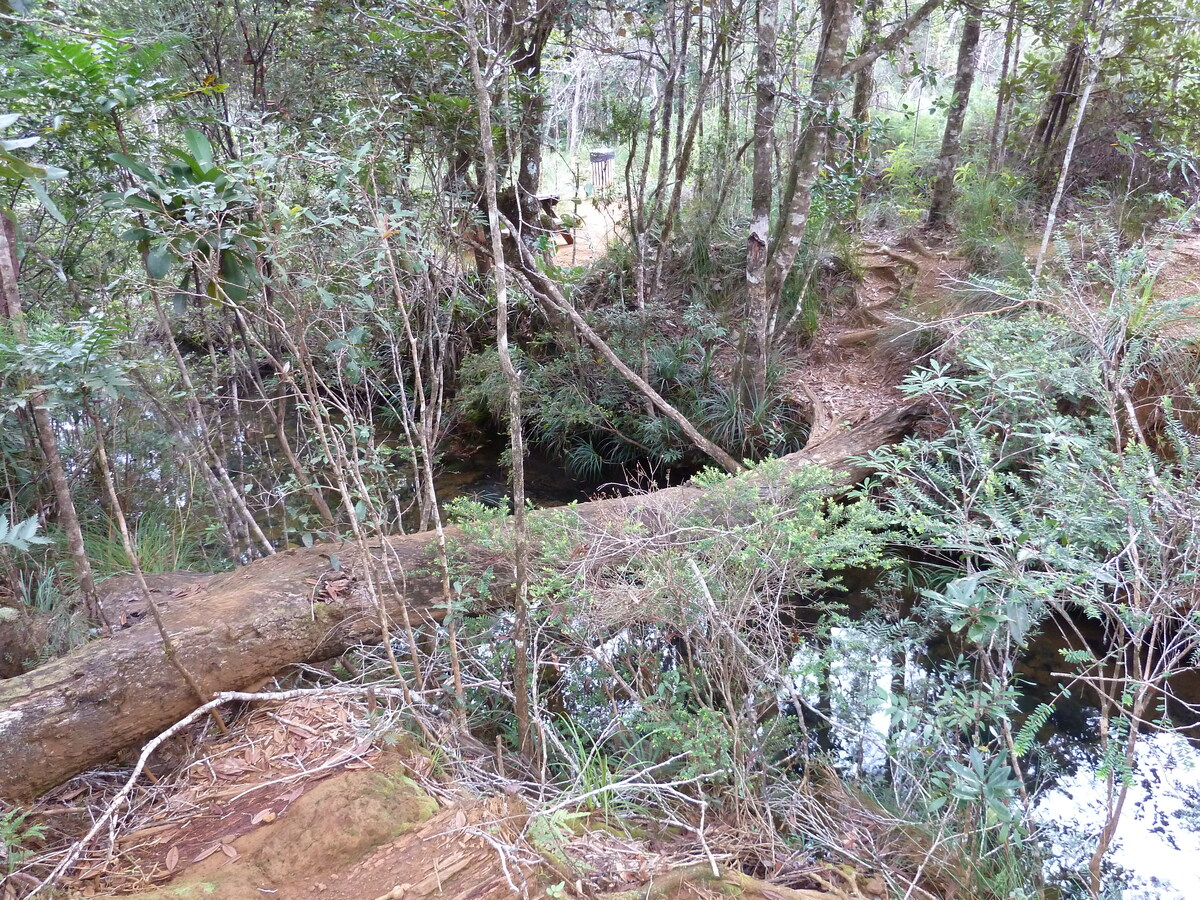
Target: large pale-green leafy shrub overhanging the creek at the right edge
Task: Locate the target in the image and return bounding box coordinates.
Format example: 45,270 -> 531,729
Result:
875,248 -> 1200,897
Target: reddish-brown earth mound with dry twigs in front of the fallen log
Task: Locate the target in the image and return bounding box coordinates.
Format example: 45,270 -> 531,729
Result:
32,696 -> 859,900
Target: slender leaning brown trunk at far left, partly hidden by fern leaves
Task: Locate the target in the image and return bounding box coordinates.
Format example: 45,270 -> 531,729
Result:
0,210 -> 108,625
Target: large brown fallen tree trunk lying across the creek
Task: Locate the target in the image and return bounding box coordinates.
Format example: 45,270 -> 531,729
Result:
0,407 -> 920,800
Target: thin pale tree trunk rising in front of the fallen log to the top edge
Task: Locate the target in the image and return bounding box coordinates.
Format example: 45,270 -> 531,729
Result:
467,0 -> 533,756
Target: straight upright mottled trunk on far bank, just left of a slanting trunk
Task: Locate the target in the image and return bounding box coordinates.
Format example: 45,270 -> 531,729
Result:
739,0 -> 779,409
